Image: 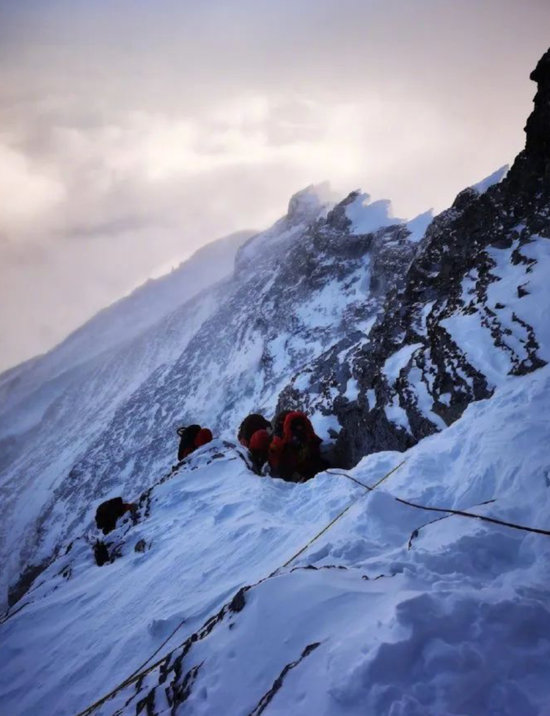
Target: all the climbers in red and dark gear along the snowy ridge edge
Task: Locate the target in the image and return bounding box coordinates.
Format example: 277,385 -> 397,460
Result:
94,410 -> 329,566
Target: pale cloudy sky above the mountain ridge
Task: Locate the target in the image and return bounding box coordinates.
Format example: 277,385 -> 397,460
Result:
0,0 -> 550,370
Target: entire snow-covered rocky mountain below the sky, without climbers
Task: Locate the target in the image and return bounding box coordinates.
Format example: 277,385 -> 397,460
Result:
0,51 -> 550,716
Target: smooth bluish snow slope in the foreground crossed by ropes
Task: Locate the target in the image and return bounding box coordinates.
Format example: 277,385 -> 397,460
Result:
0,367 -> 550,716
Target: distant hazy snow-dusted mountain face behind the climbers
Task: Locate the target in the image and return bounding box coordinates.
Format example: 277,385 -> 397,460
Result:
0,180 -> 415,604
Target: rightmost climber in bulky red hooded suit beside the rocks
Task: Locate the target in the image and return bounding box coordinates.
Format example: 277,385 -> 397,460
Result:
268,411 -> 328,482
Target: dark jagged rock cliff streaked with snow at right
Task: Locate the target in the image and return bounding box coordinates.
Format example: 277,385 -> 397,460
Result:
280,47 -> 550,466
